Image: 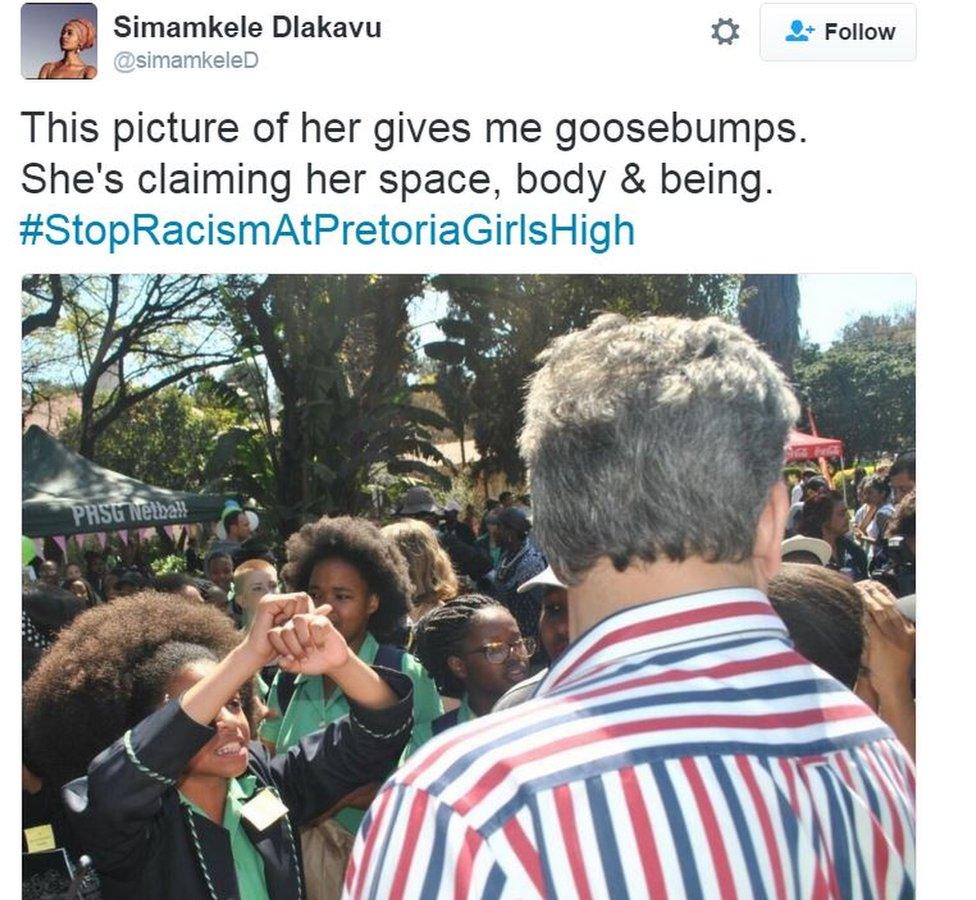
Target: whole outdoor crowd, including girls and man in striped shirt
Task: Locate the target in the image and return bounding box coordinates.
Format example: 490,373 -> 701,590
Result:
23,316 -> 915,900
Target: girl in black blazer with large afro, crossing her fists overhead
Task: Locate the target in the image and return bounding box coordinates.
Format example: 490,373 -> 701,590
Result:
25,592 -> 412,900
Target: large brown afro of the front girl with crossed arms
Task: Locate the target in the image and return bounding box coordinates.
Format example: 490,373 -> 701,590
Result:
24,591 -> 253,785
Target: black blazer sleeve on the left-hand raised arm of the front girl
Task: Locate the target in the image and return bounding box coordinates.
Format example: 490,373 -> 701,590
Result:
62,700 -> 214,872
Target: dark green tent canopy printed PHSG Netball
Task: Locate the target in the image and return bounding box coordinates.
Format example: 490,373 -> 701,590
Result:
21,425 -> 224,537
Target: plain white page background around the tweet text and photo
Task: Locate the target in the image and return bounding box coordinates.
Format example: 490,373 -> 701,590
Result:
0,0 -> 976,897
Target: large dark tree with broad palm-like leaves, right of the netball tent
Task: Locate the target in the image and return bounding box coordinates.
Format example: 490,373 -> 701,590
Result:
222,275 -> 447,535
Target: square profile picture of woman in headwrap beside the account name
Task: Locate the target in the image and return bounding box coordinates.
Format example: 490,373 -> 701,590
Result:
20,3 -> 98,80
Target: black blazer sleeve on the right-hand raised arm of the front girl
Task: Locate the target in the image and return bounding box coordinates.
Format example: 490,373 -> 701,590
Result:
270,666 -> 413,825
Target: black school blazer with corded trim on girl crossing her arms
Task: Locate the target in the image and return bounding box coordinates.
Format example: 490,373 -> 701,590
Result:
62,668 -> 413,900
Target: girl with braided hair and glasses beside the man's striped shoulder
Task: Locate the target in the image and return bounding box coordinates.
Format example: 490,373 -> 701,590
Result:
404,594 -> 535,758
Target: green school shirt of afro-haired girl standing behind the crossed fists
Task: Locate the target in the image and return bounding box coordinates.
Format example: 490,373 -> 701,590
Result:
258,632 -> 444,834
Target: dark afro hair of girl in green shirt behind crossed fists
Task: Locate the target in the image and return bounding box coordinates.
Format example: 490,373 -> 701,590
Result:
285,516 -> 413,643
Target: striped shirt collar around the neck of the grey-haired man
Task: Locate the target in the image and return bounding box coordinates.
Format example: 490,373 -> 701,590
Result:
535,587 -> 789,697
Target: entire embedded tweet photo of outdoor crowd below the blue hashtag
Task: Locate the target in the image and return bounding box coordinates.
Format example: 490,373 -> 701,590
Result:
21,273 -> 916,900
